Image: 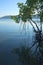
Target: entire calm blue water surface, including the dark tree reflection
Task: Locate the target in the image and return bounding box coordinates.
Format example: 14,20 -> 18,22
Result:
0,19 -> 43,65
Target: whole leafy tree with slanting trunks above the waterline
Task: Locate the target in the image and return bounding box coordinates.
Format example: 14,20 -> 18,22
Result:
13,0 -> 43,32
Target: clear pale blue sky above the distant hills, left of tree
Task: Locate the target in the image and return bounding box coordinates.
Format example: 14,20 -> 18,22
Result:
0,0 -> 26,17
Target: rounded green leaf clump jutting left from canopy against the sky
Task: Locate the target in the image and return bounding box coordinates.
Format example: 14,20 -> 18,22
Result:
18,3 -> 33,22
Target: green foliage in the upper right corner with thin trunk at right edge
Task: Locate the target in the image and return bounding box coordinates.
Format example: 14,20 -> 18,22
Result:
26,0 -> 43,32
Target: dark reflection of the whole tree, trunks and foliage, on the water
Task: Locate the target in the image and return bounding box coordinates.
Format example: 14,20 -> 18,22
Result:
12,31 -> 43,65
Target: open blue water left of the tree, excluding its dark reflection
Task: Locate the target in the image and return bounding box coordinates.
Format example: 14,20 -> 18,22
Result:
0,18 -> 42,65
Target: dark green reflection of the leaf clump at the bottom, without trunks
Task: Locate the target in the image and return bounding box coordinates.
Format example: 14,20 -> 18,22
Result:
12,46 -> 36,65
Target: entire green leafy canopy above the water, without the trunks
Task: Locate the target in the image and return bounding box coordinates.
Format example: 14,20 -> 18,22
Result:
12,0 -> 43,23
